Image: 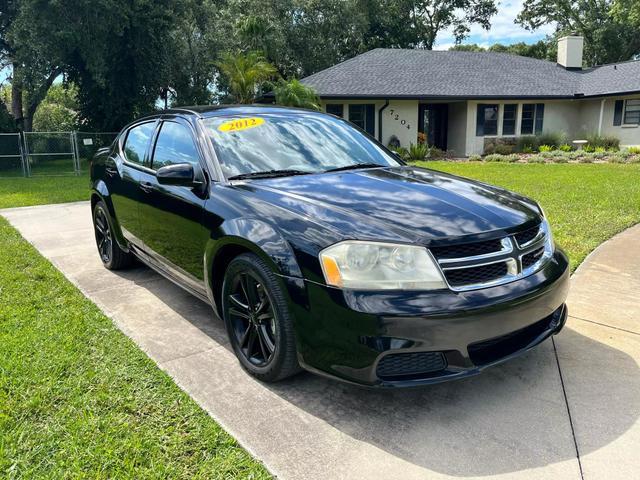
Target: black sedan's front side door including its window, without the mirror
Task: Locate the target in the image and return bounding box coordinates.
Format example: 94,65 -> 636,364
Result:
139,120 -> 209,293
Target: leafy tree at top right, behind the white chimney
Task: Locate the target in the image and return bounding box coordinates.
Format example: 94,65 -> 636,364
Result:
516,0 -> 640,65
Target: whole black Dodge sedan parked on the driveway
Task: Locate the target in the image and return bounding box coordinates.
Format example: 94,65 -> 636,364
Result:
91,106 -> 569,387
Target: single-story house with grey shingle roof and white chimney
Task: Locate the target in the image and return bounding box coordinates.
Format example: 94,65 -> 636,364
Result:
302,36 -> 640,156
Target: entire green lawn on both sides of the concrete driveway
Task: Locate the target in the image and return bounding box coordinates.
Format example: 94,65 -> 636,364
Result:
0,162 -> 640,478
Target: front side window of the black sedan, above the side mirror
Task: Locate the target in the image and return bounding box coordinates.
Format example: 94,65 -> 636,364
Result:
151,122 -> 200,170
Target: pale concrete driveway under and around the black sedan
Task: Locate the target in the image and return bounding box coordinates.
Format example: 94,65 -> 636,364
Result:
0,203 -> 640,480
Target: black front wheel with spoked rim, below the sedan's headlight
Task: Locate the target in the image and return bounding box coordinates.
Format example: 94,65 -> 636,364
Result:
222,253 -> 300,382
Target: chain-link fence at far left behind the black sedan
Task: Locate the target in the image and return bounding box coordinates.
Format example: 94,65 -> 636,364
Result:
0,132 -> 118,178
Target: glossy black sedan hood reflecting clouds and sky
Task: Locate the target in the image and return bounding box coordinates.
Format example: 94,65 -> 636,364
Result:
232,167 -> 540,244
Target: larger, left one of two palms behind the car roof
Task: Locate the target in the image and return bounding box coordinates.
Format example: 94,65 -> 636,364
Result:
217,52 -> 277,103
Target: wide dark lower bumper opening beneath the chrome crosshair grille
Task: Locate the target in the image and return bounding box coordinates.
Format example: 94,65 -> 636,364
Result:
467,312 -> 556,365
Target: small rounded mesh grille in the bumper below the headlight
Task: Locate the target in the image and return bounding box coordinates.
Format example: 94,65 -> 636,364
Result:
376,352 -> 447,380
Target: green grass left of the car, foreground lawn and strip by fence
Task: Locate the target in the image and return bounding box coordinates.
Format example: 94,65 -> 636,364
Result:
0,177 -> 270,479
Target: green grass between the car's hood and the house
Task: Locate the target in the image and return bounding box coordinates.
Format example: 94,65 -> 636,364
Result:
417,162 -> 640,270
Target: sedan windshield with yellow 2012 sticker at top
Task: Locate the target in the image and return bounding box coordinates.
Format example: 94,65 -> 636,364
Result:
204,112 -> 400,178
